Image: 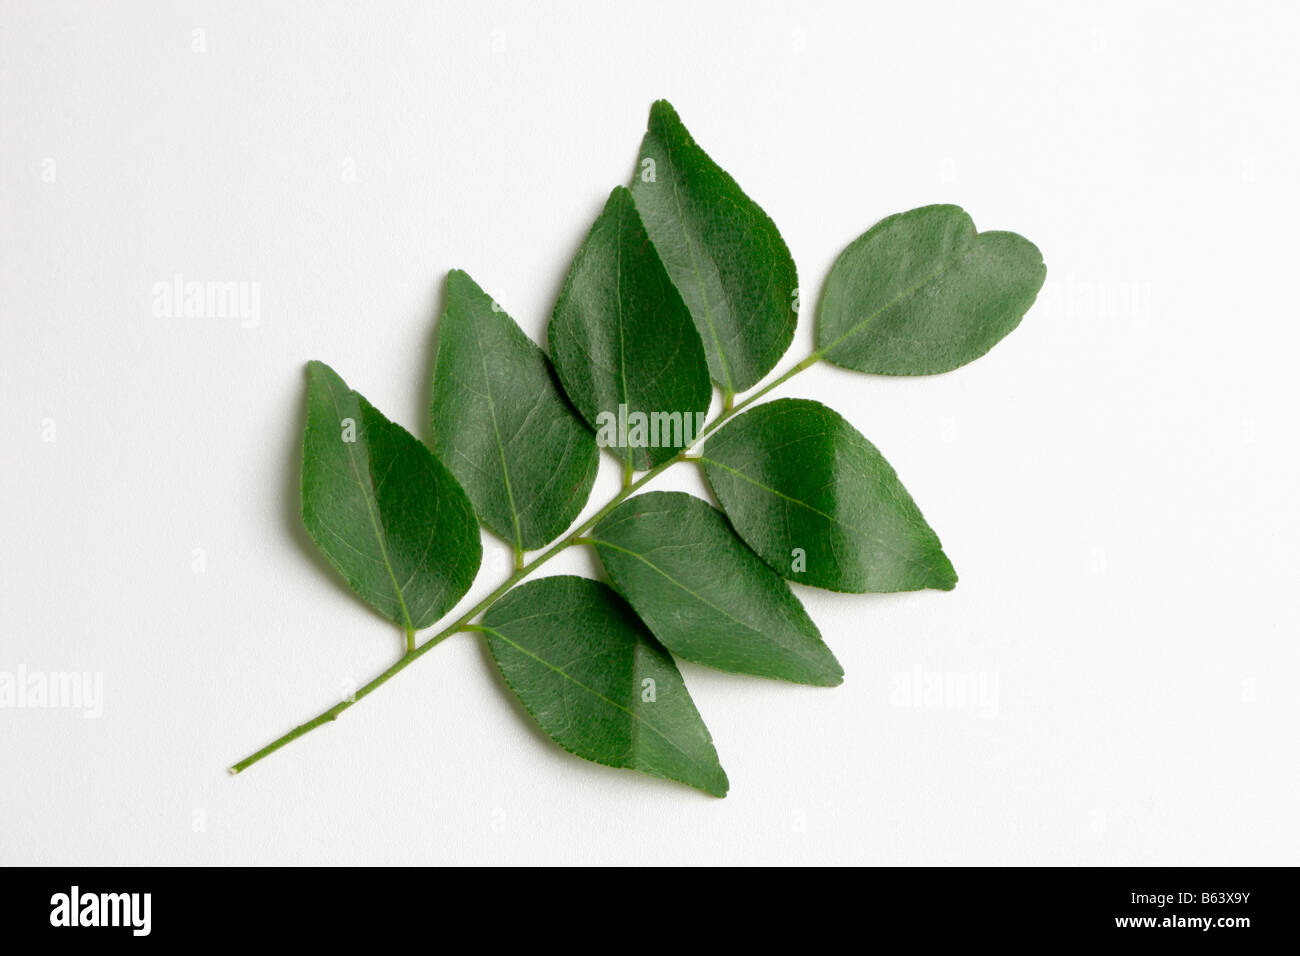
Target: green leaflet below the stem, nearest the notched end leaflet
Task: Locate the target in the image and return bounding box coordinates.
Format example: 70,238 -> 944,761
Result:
701,398 -> 957,592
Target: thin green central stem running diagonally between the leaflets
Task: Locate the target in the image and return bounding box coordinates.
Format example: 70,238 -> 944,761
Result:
230,352 -> 822,774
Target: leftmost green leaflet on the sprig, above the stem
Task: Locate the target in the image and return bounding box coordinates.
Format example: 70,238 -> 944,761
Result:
303,362 -> 482,630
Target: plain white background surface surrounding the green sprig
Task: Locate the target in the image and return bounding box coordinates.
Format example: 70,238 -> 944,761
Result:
0,0 -> 1300,864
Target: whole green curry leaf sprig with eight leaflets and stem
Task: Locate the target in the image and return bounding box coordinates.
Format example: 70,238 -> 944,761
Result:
230,101 -> 1047,796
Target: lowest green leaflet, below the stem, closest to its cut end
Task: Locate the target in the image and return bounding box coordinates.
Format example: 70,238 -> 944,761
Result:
478,576 -> 728,796
